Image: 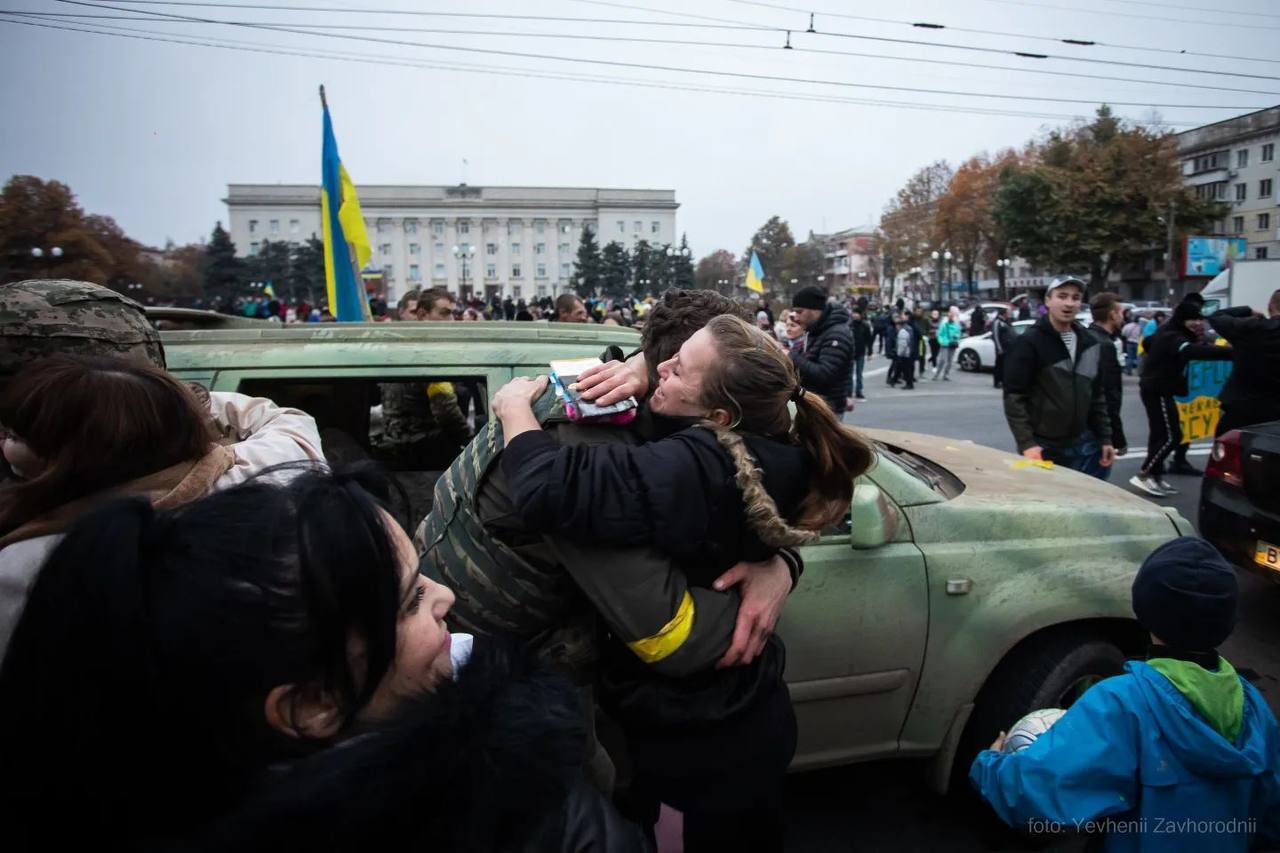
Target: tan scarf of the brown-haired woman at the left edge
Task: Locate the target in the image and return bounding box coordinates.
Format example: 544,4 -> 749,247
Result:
0,444 -> 236,548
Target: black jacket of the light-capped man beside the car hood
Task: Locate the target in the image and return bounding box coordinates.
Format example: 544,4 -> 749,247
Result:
1005,316 -> 1111,452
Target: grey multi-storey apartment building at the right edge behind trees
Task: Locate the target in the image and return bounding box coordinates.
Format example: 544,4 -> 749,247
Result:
1178,106 -> 1280,259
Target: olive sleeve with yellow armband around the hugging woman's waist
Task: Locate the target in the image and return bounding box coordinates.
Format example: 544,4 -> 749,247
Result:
550,537 -> 741,678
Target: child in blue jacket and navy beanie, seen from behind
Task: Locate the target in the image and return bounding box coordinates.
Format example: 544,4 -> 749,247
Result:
969,537 -> 1280,853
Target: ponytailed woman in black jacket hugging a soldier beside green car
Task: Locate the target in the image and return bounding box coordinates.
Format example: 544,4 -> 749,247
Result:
493,315 -> 874,852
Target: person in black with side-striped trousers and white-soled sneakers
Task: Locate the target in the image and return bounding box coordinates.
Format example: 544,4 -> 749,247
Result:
1129,302 -> 1231,497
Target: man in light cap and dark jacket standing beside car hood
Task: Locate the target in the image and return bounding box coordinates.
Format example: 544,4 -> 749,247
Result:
1002,277 -> 1115,476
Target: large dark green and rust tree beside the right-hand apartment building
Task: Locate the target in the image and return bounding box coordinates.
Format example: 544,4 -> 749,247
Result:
995,105 -> 1224,289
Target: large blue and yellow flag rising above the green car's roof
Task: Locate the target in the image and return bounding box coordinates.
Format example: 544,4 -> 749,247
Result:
320,86 -> 374,323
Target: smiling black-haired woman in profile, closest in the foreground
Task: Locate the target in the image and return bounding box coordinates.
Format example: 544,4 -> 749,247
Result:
0,471 -> 636,850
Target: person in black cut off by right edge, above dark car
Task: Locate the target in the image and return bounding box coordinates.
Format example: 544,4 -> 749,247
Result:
1208,291 -> 1280,435
